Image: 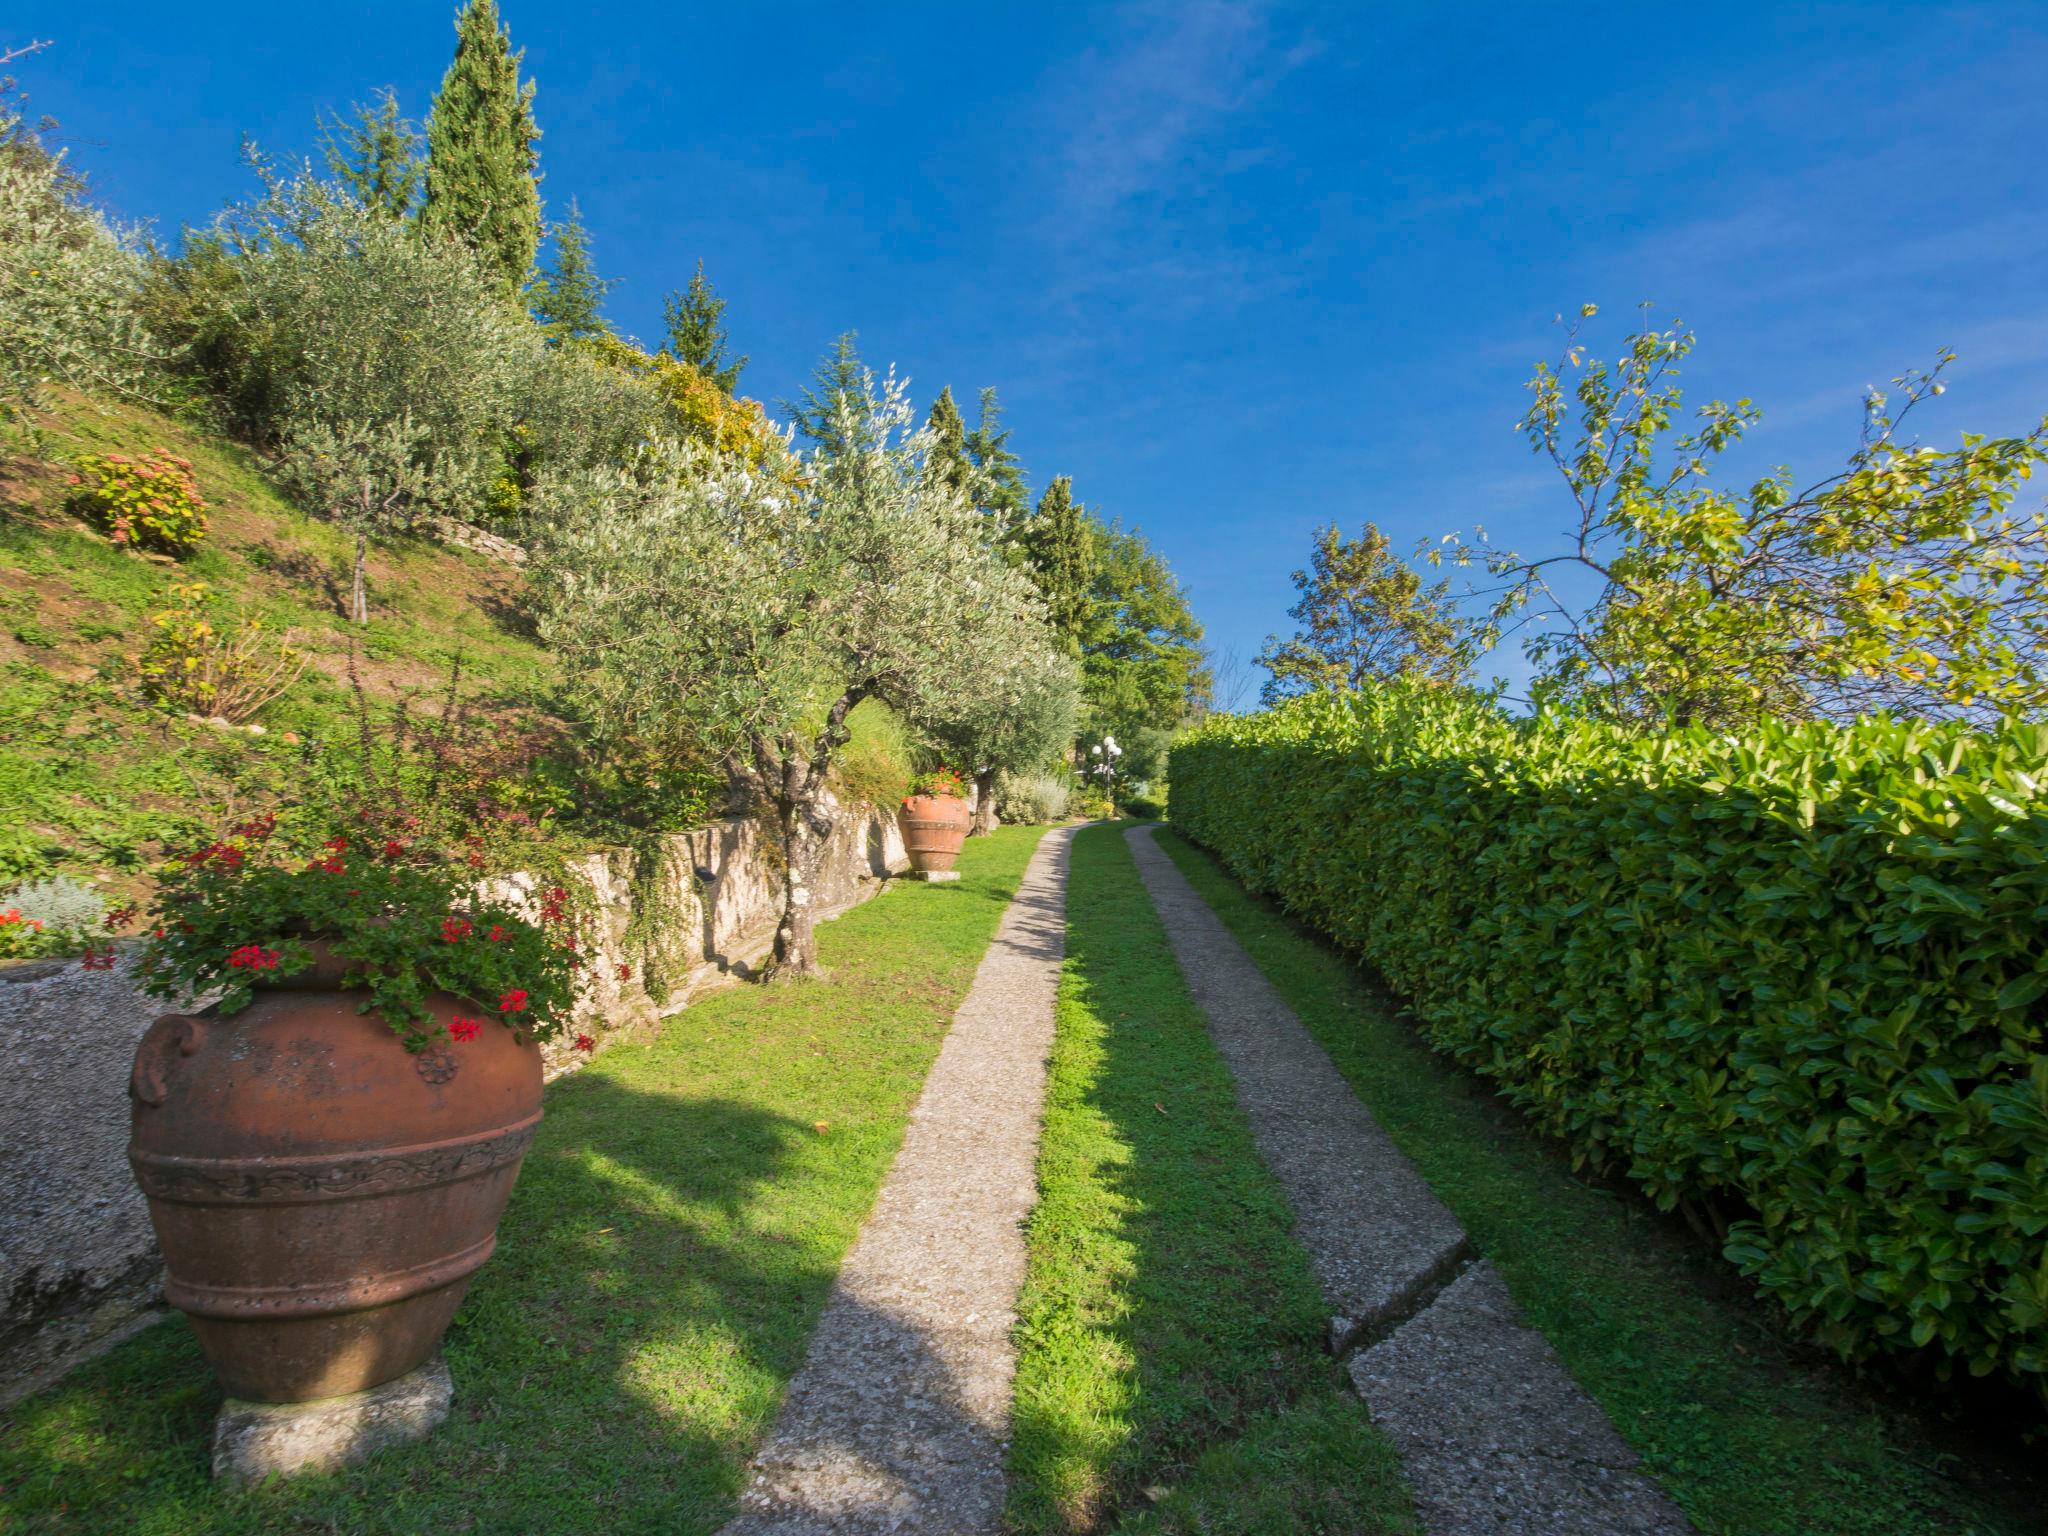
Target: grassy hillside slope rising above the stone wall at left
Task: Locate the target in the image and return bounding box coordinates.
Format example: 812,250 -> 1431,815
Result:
0,397 -> 909,901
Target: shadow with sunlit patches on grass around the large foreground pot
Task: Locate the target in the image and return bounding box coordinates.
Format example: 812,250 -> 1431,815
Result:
0,1073 -> 831,1532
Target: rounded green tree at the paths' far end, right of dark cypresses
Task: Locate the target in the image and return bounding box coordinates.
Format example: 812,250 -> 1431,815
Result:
1081,518 -> 1208,741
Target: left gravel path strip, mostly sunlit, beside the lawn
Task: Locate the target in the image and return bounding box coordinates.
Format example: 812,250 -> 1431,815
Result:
723,827 -> 1073,1536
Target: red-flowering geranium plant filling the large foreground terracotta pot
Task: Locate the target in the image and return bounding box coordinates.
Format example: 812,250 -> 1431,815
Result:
141,815 -> 580,1051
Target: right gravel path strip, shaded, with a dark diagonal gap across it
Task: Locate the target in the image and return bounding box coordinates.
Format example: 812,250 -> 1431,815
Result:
1130,827 -> 1692,1536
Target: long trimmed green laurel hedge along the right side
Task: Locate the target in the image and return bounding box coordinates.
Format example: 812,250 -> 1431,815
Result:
1171,684 -> 2048,1397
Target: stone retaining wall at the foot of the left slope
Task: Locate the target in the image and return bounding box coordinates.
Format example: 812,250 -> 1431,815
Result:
0,805 -> 907,1407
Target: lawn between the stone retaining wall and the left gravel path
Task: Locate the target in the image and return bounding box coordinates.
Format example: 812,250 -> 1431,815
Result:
0,827 -> 1040,1536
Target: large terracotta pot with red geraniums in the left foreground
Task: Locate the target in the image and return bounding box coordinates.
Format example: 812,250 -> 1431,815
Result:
129,965 -> 541,1403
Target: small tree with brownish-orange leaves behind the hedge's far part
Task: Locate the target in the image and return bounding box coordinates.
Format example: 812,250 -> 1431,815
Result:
1260,522 -> 1470,705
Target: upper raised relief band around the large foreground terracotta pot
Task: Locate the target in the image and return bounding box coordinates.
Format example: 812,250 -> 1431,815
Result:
129,1112 -> 541,1204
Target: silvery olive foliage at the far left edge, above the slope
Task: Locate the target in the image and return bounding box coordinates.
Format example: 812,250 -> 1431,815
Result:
0,113 -> 162,422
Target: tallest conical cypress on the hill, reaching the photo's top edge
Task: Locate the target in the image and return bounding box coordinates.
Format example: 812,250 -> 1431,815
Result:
420,0 -> 541,293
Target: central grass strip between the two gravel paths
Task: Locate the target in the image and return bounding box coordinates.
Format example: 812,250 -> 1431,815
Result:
1008,827 -> 1413,1536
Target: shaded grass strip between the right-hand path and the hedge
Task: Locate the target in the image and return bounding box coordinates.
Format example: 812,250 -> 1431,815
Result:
1159,834 -> 2040,1536
